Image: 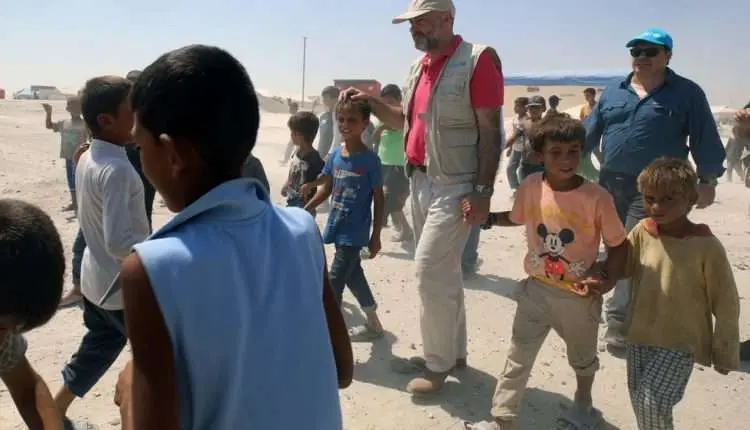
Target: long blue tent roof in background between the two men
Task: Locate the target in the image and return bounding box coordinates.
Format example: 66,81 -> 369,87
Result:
505,69 -> 630,87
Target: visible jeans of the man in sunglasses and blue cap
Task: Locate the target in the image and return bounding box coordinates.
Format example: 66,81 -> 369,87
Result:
599,170 -> 646,324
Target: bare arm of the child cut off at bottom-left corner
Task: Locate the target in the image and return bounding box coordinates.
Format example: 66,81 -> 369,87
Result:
0,357 -> 63,430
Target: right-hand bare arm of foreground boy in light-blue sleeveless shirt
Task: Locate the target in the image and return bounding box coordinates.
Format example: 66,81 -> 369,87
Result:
323,262 -> 354,388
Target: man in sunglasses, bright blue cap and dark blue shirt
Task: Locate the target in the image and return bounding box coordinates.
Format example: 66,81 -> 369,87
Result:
584,28 -> 725,347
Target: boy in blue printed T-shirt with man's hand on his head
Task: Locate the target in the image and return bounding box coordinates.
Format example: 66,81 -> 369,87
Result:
300,100 -> 385,342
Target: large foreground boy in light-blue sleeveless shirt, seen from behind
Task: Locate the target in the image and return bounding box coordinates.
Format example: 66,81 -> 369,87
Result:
111,45 -> 352,430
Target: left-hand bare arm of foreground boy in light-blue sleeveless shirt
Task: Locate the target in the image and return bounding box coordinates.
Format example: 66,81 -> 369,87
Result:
120,253 -> 180,430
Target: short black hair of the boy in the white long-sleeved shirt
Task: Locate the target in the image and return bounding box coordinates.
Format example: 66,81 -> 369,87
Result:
81,76 -> 130,135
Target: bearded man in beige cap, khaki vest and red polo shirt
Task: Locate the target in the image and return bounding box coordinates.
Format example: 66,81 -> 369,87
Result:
343,0 -> 503,394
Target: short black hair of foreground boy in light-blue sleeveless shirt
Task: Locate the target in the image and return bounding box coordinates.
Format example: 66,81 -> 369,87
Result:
131,45 -> 260,178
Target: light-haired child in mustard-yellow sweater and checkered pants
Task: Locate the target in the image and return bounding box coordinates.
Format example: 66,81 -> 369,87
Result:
605,158 -> 740,430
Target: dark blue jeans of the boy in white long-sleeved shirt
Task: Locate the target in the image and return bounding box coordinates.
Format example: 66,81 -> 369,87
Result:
62,298 -> 127,397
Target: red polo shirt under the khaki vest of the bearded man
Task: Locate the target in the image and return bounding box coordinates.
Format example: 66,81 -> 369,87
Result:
406,36 -> 504,166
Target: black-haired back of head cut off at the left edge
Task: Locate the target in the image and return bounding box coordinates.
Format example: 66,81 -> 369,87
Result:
0,199 -> 65,331
